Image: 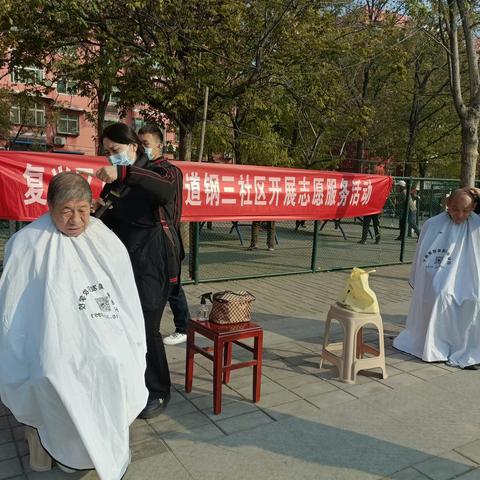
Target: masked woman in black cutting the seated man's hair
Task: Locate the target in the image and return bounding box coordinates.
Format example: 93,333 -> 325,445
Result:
93,123 -> 183,418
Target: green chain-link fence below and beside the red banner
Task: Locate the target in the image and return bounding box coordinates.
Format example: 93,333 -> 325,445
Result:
0,177 -> 470,283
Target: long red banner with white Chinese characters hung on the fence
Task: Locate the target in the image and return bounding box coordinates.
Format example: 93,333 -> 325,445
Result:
0,151 -> 392,221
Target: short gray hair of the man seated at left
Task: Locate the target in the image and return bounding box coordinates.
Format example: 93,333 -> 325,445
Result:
47,172 -> 92,207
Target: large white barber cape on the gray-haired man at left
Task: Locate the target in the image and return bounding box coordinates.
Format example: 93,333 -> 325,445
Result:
0,214 -> 148,480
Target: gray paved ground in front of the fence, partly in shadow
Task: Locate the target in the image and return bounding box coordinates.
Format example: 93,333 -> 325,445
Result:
0,266 -> 480,480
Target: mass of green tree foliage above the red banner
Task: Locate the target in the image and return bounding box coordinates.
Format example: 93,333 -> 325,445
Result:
0,0 -> 460,174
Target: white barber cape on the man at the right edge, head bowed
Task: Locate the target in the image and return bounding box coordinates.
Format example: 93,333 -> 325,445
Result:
393,212 -> 480,368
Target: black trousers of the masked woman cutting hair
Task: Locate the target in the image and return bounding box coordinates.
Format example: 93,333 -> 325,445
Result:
143,306 -> 171,400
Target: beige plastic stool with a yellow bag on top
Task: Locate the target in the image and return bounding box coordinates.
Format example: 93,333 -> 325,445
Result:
320,303 -> 387,383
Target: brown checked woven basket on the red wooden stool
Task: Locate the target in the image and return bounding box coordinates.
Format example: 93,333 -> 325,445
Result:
209,290 -> 255,324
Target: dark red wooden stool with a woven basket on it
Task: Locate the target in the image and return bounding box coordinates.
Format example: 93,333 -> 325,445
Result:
185,319 -> 263,415
